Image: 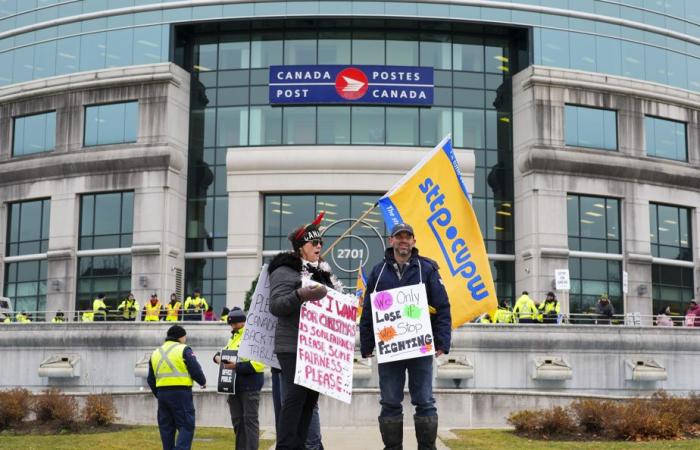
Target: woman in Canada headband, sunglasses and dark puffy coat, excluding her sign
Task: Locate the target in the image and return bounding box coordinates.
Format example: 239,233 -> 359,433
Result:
268,214 -> 342,449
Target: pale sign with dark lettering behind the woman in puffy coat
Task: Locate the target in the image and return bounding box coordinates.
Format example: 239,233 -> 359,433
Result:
238,264 -> 280,369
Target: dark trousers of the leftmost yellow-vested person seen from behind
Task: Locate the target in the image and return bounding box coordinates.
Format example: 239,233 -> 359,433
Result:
158,389 -> 194,450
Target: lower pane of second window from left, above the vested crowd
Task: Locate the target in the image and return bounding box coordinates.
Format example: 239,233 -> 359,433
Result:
75,255 -> 131,317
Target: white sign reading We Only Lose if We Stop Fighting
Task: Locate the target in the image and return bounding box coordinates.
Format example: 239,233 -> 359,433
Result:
370,283 -> 435,364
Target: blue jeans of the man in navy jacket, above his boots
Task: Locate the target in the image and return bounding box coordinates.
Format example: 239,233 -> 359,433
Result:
379,356 -> 437,417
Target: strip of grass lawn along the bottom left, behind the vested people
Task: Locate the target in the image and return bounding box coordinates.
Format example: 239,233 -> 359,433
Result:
0,427 -> 273,450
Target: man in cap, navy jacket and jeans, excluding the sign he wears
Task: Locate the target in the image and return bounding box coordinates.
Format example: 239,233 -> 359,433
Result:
360,223 -> 452,450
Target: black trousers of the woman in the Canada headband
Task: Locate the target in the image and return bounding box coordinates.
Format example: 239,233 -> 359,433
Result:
275,353 -> 318,450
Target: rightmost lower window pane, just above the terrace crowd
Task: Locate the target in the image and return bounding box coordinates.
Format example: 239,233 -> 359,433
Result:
651,264 -> 695,316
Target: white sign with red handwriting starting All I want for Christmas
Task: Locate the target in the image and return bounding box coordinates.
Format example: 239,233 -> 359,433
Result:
294,280 -> 357,403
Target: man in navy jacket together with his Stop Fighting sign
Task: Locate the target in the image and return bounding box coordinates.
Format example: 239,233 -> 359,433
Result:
360,223 -> 452,449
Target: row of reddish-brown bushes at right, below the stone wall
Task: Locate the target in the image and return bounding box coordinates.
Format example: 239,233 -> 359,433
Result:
508,391 -> 700,441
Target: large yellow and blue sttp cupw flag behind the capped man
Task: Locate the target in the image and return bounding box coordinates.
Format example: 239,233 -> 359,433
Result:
379,136 -> 498,328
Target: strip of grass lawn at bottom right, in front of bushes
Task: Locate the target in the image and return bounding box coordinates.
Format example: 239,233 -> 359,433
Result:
446,430 -> 700,450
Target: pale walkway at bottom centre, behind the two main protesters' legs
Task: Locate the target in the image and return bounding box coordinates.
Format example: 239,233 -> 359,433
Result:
262,428 -> 451,450
